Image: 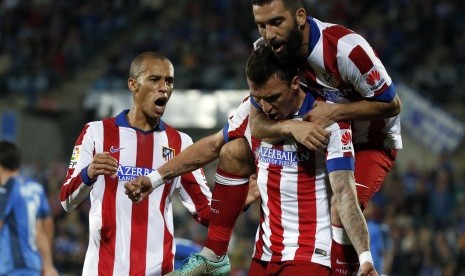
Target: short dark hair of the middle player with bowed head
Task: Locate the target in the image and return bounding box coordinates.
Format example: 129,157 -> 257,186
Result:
246,45 -> 298,86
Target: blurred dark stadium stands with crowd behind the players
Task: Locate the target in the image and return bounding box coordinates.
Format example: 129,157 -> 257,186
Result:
0,0 -> 465,275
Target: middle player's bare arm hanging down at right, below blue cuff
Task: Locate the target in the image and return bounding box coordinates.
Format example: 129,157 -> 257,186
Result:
329,170 -> 370,265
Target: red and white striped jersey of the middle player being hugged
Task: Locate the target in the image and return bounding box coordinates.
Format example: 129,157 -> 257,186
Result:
224,93 -> 354,266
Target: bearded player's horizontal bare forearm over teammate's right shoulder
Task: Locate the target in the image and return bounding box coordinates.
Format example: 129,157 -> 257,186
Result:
304,95 -> 401,127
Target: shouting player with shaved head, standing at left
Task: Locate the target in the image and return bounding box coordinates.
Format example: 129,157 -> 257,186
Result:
60,52 -> 211,275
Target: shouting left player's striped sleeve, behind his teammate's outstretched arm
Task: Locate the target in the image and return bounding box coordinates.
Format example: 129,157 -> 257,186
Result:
175,134 -> 212,226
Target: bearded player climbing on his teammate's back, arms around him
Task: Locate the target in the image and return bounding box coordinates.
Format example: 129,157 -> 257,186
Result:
251,0 -> 402,275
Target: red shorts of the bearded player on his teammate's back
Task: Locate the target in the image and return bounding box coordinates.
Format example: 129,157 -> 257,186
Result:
354,147 -> 397,209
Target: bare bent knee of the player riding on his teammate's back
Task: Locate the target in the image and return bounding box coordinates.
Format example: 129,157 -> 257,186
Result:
218,138 -> 256,176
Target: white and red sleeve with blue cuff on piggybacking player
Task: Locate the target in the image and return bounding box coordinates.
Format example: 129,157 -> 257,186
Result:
338,34 -> 396,102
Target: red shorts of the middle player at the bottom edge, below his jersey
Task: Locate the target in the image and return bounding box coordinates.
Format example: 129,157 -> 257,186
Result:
248,259 -> 331,276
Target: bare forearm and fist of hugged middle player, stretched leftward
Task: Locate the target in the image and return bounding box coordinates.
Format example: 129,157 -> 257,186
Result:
124,131 -> 225,202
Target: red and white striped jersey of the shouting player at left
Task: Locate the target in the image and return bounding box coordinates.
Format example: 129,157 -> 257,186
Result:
60,110 -> 211,275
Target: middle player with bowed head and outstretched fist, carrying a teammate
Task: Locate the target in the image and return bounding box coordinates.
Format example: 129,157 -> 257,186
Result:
126,47 -> 376,275
